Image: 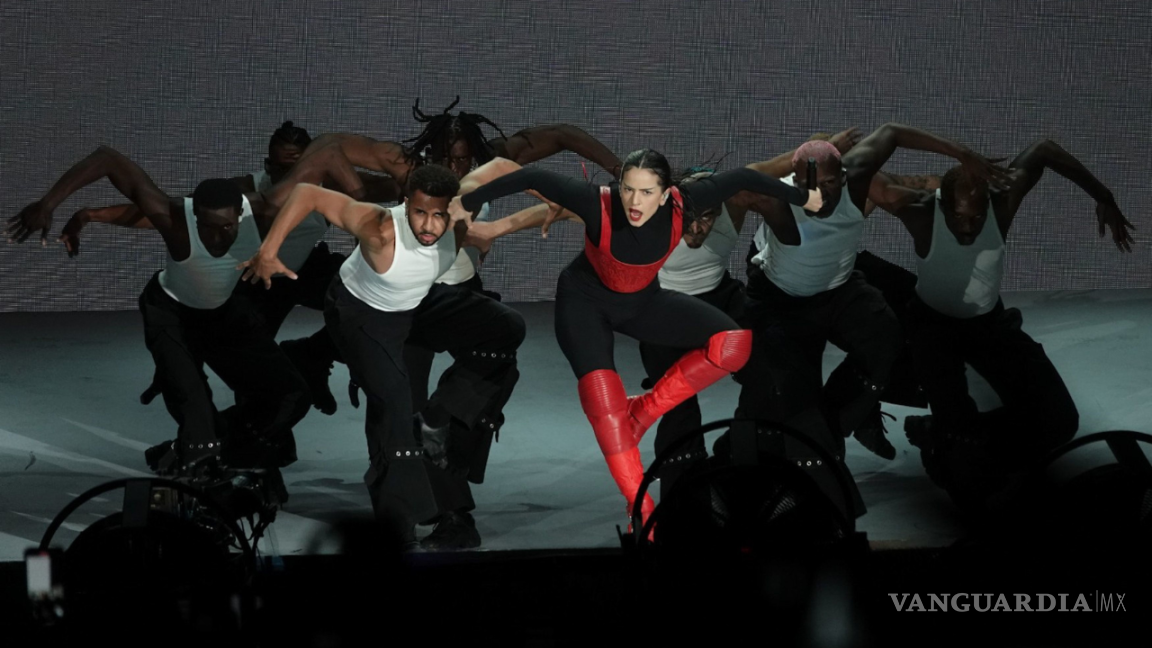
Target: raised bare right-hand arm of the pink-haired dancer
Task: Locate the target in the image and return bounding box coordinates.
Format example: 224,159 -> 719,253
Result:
843,123 -> 1009,188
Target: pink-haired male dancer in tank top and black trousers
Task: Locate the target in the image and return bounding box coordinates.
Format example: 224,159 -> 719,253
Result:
738,123 -> 1005,515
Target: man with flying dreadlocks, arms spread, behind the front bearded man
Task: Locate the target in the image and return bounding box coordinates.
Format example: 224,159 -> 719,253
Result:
285,104 -> 620,550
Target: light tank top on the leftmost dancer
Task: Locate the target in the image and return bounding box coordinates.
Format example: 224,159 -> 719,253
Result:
160,196 -> 260,310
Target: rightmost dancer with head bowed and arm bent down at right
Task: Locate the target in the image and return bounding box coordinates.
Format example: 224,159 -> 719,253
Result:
873,140 -> 1132,511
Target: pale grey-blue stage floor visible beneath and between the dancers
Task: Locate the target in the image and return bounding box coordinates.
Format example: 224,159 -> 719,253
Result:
0,291 -> 1152,562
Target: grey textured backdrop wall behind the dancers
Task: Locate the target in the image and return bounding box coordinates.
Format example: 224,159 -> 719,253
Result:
0,0 -> 1152,311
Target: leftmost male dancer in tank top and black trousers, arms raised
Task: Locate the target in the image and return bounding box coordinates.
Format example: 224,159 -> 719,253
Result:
8,146 -> 364,468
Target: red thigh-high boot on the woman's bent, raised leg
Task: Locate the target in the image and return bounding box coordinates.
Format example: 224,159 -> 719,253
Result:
628,331 -> 752,444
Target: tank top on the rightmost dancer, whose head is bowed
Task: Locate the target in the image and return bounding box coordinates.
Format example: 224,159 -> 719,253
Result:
916,189 -> 1005,319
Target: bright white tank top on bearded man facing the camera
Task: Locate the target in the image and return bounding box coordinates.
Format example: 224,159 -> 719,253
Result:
340,204 -> 456,312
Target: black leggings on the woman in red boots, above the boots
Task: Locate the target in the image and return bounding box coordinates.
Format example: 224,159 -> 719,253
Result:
555,254 -> 740,378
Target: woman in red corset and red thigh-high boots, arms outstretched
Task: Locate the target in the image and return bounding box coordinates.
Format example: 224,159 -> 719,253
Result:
452,149 -> 820,525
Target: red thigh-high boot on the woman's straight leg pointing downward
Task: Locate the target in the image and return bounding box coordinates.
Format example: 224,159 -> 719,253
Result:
578,369 -> 655,530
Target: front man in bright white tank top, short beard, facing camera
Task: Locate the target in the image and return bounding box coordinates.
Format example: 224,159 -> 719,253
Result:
243,165 -> 509,543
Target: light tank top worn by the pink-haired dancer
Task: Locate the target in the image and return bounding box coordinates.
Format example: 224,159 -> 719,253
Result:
752,178 -> 864,297
